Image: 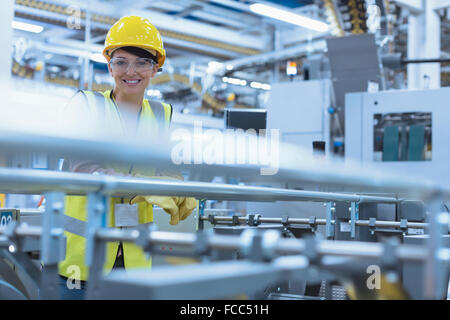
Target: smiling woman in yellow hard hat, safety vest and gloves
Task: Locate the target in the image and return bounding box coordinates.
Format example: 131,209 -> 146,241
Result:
59,16 -> 196,299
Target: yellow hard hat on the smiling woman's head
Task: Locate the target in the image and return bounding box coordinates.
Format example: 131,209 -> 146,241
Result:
103,16 -> 166,68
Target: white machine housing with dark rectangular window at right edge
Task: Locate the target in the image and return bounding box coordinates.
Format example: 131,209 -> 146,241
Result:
345,88 -> 450,189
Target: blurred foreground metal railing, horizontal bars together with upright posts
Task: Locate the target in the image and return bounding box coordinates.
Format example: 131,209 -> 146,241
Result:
0,130 -> 450,298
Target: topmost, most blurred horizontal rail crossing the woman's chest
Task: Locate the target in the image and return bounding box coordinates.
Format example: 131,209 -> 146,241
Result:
0,130 -> 444,199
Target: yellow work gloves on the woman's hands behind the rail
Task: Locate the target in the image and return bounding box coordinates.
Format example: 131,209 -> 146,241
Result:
130,176 -> 197,225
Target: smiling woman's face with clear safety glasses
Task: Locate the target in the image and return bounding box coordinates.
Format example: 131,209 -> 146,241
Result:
108,49 -> 158,95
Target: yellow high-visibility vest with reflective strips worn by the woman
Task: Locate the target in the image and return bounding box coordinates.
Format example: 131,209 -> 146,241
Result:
59,90 -> 172,281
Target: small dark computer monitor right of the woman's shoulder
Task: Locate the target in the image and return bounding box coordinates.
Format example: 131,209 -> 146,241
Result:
225,109 -> 267,133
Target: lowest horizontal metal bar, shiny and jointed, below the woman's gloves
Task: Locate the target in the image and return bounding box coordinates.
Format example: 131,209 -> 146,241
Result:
0,226 -> 428,261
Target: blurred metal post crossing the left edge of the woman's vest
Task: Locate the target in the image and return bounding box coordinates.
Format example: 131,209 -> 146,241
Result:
40,192 -> 66,299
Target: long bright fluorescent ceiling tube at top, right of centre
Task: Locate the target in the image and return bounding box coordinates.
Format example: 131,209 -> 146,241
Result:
250,3 -> 329,32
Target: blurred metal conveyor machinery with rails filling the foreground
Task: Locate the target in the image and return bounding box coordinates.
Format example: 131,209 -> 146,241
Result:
0,132 -> 450,300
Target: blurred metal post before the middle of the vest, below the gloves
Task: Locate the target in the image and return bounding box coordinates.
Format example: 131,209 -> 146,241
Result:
85,192 -> 109,299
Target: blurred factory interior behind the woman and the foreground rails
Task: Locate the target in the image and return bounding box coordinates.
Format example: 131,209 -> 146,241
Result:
0,0 -> 450,298
